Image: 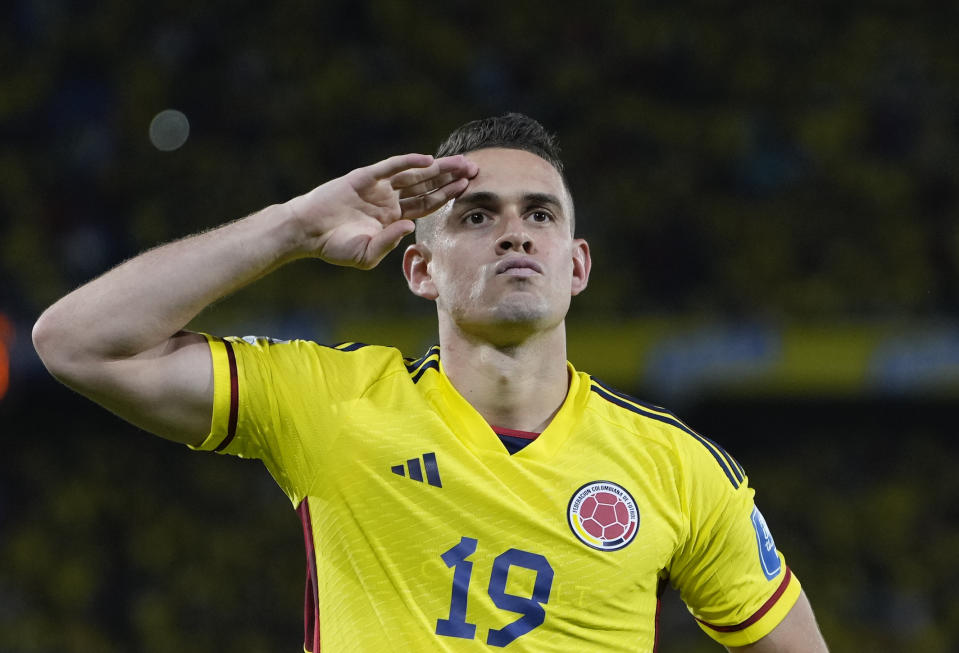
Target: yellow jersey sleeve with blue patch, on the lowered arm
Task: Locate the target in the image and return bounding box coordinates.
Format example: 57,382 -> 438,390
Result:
669,437 -> 801,646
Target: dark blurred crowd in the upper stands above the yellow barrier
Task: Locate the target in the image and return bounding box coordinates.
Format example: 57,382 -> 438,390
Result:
0,0 -> 959,326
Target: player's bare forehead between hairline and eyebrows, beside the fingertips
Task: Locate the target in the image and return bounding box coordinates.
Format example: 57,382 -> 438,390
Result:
465,147 -> 570,205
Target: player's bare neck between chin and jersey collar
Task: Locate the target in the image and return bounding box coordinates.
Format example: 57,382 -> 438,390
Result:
439,320 -> 569,432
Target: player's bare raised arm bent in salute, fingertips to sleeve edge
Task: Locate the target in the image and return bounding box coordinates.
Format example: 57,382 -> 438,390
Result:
33,154 -> 476,444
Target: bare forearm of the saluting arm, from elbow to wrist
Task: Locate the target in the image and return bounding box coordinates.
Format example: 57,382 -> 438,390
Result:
34,205 -> 300,366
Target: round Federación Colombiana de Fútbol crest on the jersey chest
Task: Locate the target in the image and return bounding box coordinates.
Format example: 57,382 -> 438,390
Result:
566,481 -> 639,551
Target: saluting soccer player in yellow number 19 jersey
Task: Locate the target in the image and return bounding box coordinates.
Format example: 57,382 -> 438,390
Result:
34,114 -> 825,653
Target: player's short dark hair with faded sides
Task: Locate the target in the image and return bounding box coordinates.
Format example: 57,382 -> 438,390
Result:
416,112 -> 573,240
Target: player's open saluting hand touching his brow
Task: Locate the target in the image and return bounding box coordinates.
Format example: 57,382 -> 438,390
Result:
287,154 -> 479,270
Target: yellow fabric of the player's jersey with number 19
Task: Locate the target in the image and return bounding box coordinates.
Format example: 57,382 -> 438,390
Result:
191,338 -> 799,653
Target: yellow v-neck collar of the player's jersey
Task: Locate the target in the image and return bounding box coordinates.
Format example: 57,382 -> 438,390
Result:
417,347 -> 589,461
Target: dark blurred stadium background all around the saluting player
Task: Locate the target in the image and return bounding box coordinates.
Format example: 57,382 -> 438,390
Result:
0,0 -> 959,653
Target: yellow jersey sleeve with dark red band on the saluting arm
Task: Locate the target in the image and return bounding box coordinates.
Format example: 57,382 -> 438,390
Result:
192,334 -> 398,505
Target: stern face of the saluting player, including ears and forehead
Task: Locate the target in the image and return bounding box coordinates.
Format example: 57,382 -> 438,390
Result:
403,148 -> 590,344
